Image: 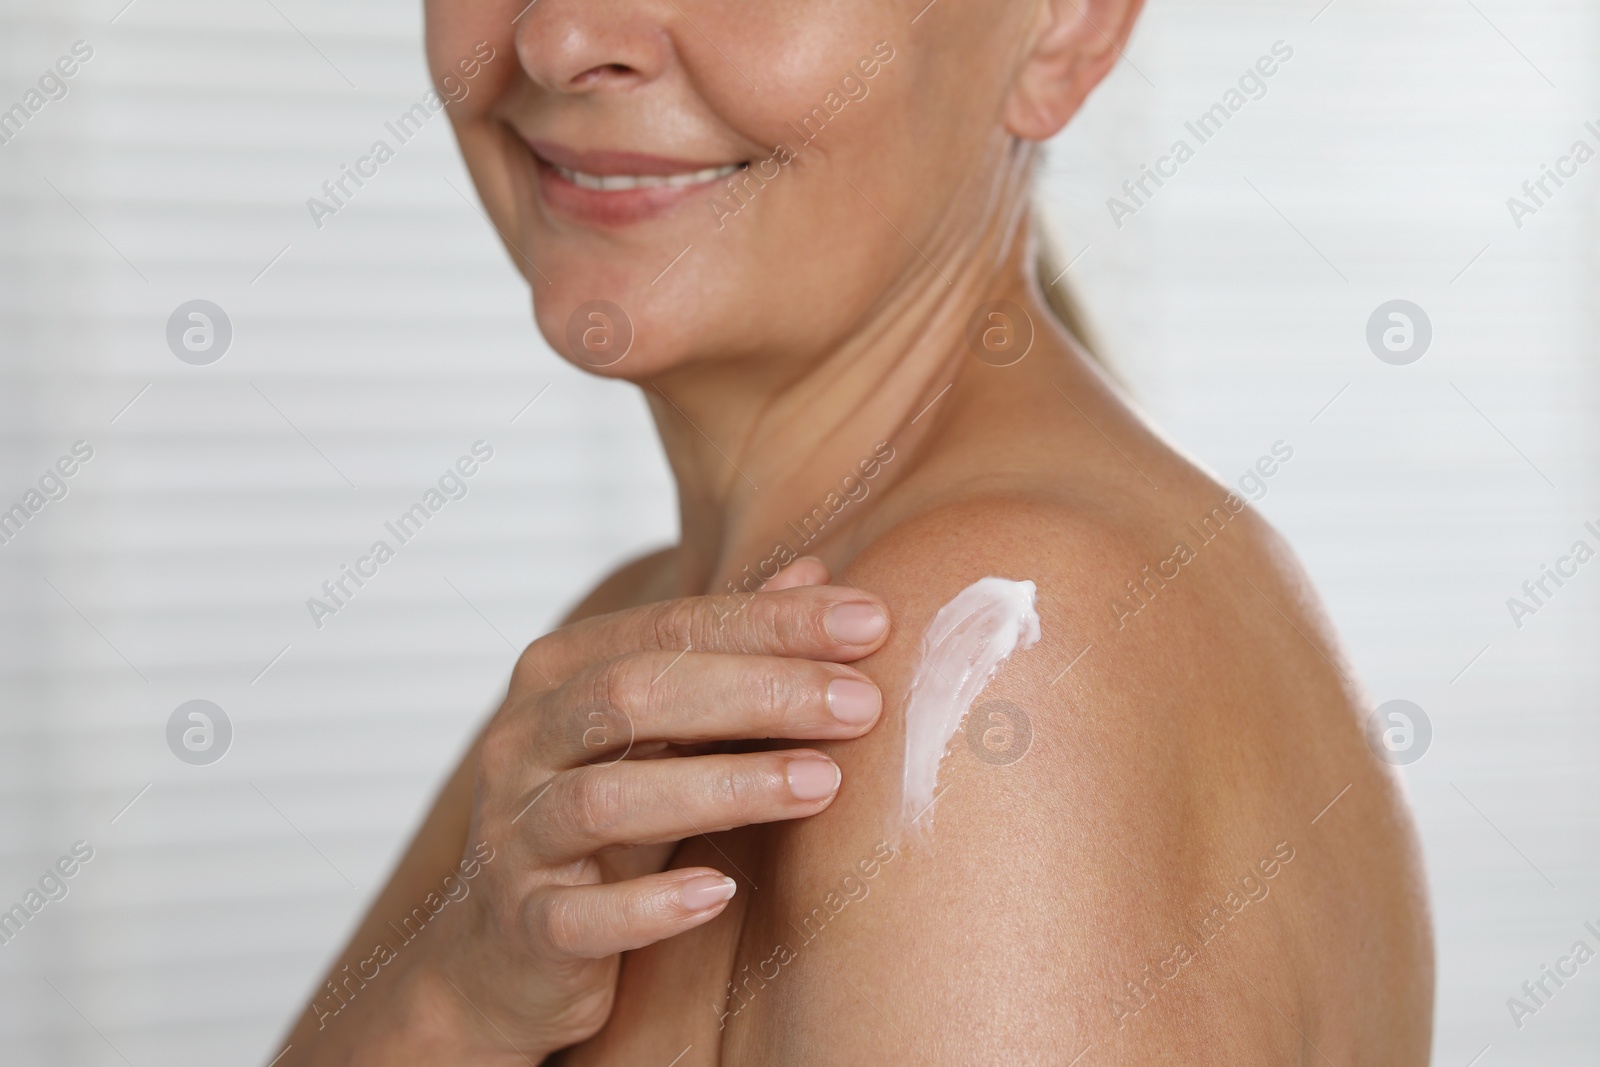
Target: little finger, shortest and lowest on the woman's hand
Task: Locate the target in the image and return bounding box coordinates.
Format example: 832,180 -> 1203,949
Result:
528,867 -> 738,960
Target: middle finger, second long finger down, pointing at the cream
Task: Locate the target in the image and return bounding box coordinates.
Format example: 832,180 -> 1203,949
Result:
547,653 -> 883,766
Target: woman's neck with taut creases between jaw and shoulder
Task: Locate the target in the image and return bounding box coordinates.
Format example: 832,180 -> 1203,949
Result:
640,135 -> 1050,595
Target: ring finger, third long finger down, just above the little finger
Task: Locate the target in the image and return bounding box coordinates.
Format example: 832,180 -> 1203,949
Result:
523,749 -> 840,864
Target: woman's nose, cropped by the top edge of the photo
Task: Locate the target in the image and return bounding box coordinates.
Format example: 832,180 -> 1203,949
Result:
517,0 -> 674,93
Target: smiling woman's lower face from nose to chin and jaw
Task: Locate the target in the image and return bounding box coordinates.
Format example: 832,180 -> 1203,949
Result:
427,0 -> 1034,379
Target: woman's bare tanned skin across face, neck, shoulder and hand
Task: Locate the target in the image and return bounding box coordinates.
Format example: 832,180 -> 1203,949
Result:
283,0 -> 1432,1067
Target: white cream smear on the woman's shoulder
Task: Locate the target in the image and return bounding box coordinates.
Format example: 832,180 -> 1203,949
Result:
901,577 -> 1038,833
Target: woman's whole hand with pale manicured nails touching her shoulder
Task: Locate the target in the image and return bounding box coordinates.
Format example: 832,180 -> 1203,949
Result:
395,560 -> 888,1062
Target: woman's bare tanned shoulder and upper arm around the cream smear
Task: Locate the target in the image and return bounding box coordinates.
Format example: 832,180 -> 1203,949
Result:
739,480 -> 1430,1067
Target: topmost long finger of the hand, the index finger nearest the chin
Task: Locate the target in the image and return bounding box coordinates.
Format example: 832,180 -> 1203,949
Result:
531,585 -> 888,680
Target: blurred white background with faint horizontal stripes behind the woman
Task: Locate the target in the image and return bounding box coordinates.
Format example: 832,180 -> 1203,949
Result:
0,0 -> 1600,1067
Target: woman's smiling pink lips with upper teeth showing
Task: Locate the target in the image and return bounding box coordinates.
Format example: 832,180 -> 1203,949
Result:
528,141 -> 744,226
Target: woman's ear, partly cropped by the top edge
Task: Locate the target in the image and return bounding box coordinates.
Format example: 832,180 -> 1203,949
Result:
1003,0 -> 1144,141
